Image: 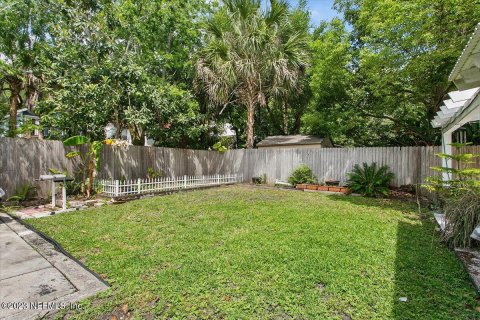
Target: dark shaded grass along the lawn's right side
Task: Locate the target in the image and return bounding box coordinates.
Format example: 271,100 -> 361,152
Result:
329,195 -> 480,319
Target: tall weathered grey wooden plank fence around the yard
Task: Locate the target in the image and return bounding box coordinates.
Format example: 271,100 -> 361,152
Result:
0,138 -> 480,196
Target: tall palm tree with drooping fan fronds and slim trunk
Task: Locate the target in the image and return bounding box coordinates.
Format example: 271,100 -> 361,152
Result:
196,0 -> 307,148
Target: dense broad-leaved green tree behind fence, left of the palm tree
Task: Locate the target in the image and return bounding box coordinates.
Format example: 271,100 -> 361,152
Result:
36,0 -> 207,147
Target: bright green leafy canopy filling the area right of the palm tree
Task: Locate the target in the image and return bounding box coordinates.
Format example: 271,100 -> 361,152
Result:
304,0 -> 480,146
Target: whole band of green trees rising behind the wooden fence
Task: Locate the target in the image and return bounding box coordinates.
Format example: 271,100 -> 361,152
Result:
0,0 -> 480,148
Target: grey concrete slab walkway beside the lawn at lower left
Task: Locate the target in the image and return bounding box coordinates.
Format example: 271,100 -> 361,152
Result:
0,213 -> 108,319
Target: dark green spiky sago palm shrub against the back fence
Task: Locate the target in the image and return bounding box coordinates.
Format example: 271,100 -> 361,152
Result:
347,162 -> 394,197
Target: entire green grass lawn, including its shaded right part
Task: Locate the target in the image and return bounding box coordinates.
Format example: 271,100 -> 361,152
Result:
28,186 -> 479,319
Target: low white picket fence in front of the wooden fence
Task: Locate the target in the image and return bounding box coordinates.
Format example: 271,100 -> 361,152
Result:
98,174 -> 242,197
